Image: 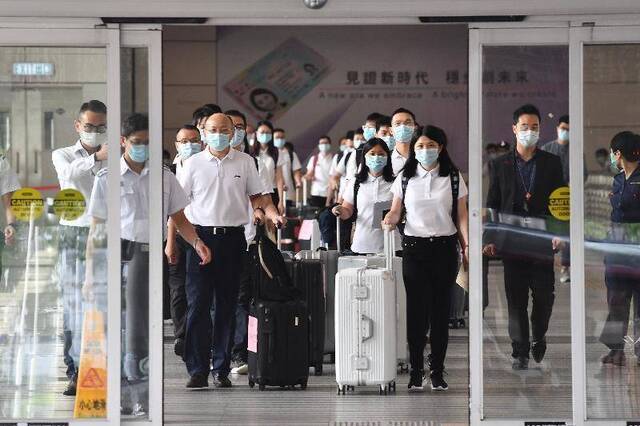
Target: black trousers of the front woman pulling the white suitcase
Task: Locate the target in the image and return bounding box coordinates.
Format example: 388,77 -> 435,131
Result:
402,235 -> 458,372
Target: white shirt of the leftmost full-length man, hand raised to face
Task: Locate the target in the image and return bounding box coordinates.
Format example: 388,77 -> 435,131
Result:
51,140 -> 106,227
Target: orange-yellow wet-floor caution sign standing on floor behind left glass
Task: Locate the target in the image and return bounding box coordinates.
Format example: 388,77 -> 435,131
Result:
73,309 -> 107,419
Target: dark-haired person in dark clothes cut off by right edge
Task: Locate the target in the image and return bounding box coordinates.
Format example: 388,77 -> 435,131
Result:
600,131 -> 640,367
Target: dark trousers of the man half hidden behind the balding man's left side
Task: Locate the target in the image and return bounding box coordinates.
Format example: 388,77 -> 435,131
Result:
169,235 -> 191,339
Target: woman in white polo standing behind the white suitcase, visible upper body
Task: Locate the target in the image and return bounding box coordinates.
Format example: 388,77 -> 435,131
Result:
333,138 -> 393,254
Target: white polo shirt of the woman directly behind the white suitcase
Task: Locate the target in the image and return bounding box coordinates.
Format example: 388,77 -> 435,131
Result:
344,175 -> 400,254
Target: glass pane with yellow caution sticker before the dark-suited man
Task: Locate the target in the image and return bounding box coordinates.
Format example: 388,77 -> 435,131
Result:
476,46 -> 571,419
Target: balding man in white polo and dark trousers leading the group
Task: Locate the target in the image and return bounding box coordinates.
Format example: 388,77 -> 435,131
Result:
180,114 -> 284,388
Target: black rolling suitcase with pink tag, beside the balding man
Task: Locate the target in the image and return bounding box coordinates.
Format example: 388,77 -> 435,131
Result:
248,300 -> 309,390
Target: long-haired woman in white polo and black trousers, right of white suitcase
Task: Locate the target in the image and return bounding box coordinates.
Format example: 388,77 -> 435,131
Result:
384,126 -> 469,392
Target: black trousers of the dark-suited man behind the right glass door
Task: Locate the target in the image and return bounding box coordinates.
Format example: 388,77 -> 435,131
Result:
503,259 -> 555,358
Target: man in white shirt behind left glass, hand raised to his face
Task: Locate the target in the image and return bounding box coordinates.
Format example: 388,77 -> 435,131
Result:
51,100 -> 107,396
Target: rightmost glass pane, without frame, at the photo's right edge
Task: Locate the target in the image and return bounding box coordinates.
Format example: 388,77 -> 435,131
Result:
583,44 -> 640,419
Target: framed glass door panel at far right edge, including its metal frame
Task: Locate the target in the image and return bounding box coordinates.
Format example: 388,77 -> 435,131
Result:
571,23 -> 640,426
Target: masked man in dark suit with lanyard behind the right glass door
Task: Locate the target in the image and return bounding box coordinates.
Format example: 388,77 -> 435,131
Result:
483,105 -> 565,370
